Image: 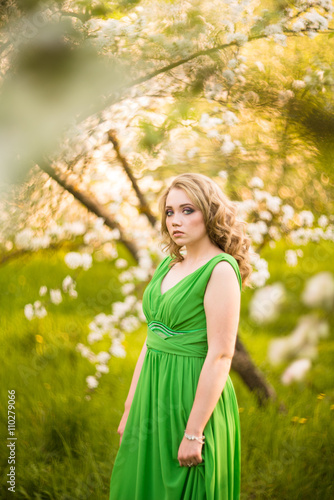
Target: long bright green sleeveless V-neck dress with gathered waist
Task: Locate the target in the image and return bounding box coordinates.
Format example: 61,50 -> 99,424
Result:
109,253 -> 242,500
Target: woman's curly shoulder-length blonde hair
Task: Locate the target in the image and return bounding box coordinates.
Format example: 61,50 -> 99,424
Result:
159,172 -> 252,288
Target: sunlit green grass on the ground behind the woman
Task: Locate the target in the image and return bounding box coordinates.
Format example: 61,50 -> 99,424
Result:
0,242 -> 334,500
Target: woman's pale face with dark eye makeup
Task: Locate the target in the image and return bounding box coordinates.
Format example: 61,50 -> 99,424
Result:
165,188 -> 207,247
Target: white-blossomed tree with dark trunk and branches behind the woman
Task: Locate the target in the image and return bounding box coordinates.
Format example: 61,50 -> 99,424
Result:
0,0 -> 334,398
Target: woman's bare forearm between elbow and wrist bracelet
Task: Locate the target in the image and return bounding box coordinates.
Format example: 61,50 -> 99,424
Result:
186,355 -> 232,436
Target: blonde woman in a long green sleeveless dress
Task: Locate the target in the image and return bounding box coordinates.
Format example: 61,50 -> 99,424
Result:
110,173 -> 251,500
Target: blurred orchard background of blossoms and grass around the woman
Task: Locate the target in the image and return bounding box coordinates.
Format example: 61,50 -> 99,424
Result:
0,0 -> 334,500
